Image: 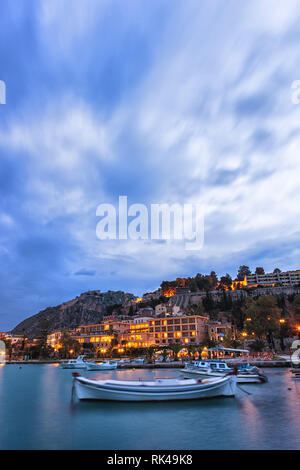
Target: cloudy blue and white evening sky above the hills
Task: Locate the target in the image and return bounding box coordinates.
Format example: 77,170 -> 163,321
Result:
0,0 -> 300,331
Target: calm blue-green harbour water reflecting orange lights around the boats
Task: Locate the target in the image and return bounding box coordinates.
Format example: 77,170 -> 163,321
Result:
0,364 -> 300,450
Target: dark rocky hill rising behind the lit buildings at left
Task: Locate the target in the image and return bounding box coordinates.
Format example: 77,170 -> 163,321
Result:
12,291 -> 134,338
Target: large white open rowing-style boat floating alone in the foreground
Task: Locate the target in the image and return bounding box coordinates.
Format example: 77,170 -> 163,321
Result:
73,372 -> 236,401
